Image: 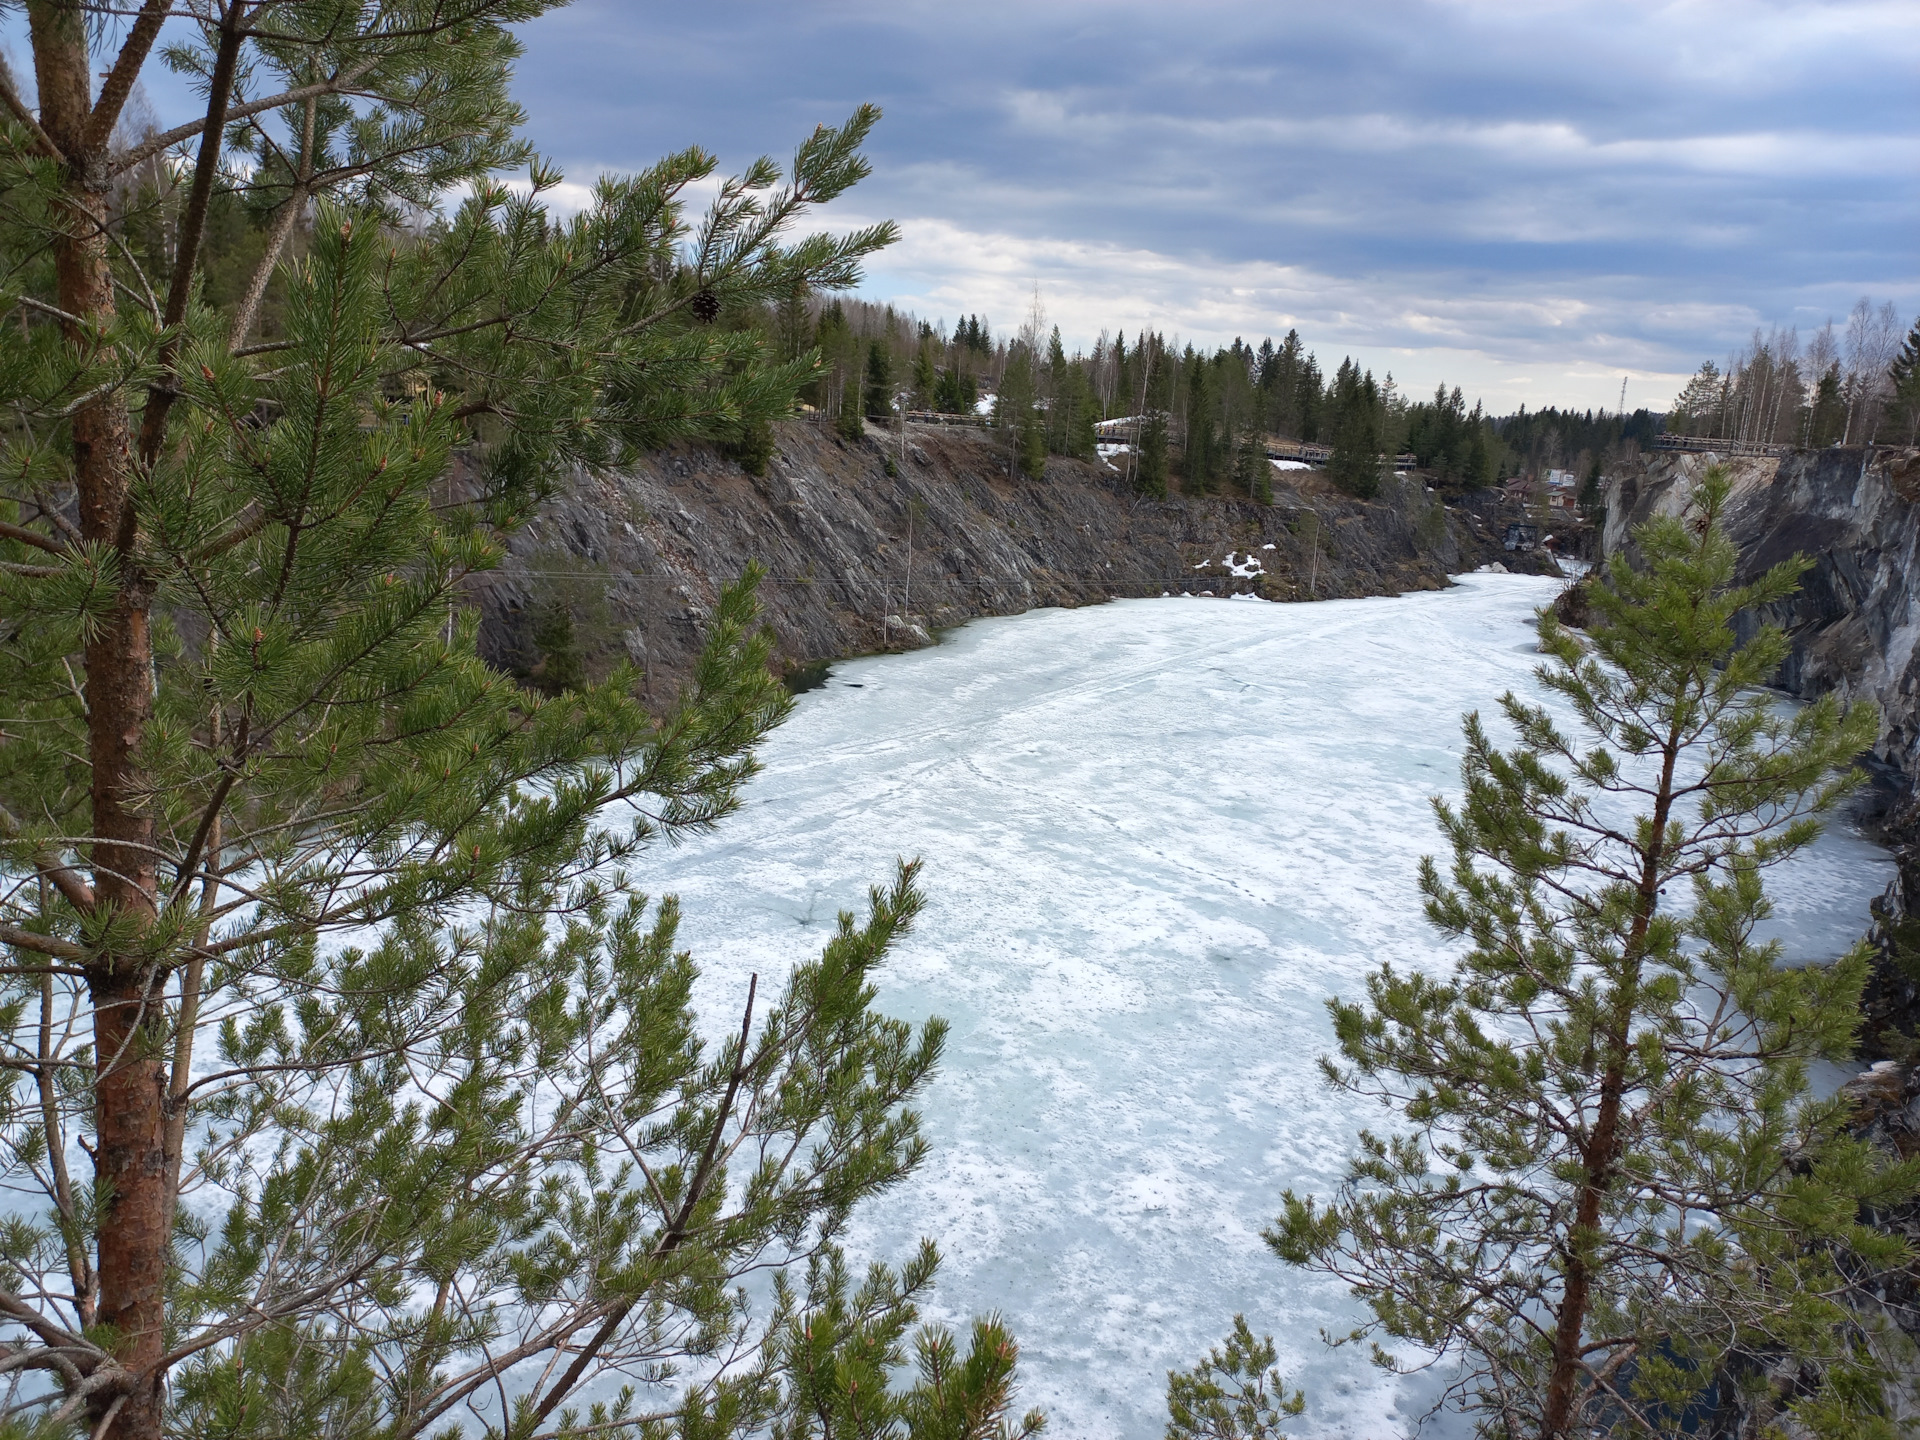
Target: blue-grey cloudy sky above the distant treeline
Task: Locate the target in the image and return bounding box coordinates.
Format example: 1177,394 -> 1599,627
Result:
503,0 -> 1920,409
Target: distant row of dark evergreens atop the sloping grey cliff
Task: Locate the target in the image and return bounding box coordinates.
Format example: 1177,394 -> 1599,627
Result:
724,296 -> 1665,497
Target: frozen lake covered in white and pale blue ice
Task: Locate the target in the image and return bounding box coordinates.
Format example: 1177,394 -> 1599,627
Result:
641,576 -> 1891,1440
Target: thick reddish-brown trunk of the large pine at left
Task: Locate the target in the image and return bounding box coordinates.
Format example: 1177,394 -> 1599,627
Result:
29,0 -> 167,1440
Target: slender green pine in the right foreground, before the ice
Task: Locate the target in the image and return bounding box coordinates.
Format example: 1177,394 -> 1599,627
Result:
1269,467 -> 1920,1440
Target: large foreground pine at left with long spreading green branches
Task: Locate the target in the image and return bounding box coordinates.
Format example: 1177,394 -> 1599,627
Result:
0,11 -> 1036,1440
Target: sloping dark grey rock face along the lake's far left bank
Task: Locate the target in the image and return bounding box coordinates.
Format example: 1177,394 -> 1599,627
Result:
476,420 -> 1549,701
